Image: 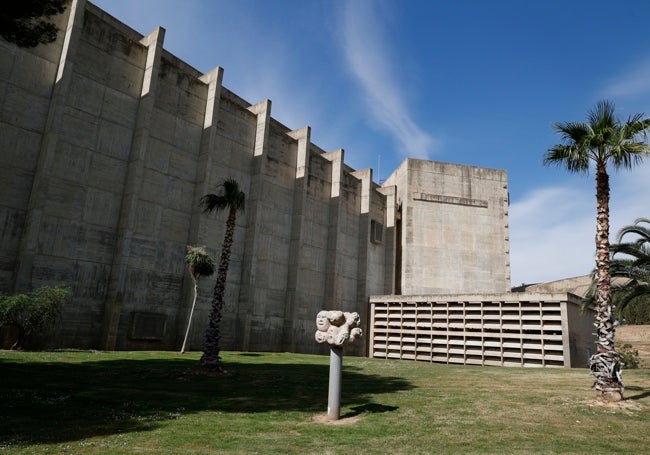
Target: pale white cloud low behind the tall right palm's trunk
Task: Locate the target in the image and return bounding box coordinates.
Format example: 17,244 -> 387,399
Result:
510,160 -> 650,286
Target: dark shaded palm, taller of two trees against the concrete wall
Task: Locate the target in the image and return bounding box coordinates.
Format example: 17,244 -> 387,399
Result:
200,179 -> 246,372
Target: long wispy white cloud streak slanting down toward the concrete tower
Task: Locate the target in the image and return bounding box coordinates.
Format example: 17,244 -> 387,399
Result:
342,0 -> 439,158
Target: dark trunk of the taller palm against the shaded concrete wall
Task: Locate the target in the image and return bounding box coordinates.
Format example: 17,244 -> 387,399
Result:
201,208 -> 237,371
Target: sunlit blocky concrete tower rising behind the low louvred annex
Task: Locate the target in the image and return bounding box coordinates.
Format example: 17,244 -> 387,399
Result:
386,159 -> 510,295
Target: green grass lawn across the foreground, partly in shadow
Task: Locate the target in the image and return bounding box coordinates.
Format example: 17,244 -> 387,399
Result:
0,351 -> 650,455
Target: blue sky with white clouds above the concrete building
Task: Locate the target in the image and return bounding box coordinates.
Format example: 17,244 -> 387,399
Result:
93,0 -> 650,286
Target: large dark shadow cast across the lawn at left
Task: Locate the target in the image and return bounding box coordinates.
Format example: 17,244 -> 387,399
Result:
0,354 -> 413,448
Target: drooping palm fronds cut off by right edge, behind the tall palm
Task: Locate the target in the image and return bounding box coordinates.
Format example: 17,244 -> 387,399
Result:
611,218 -> 650,313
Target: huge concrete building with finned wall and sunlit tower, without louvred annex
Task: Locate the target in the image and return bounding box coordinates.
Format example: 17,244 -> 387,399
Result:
0,0 -> 510,353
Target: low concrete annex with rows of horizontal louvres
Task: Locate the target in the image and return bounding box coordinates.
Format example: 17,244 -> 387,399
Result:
369,293 -> 593,367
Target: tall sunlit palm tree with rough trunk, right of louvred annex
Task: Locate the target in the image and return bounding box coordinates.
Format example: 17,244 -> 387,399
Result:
544,101 -> 650,401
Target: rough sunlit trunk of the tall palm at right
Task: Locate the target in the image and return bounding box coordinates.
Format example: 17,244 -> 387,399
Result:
589,166 -> 624,401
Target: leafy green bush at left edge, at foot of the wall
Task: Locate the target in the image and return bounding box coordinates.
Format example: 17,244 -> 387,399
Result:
0,286 -> 72,349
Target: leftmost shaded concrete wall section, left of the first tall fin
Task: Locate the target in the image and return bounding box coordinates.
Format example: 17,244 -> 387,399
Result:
0,3 -> 68,292
